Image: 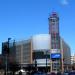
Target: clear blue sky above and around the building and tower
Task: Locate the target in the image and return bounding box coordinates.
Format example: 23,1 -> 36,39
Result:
0,0 -> 75,54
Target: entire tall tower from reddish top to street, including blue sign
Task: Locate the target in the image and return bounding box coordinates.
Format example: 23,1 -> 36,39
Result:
49,12 -> 61,72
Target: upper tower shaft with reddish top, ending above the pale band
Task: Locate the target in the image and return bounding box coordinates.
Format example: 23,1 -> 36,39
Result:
49,12 -> 60,49
